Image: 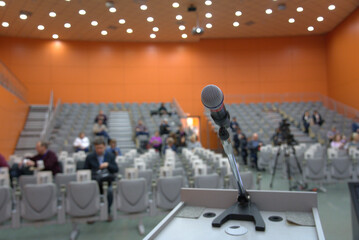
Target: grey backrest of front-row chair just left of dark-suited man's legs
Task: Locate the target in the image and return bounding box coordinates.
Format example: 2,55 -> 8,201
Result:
66,181 -> 100,217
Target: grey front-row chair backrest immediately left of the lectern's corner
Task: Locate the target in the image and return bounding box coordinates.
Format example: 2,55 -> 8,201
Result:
156,176 -> 183,210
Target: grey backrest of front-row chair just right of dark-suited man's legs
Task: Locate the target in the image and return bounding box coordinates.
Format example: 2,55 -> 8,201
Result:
116,178 -> 149,213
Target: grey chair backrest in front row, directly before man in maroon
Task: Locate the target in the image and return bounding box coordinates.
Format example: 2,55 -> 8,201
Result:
20,183 -> 57,221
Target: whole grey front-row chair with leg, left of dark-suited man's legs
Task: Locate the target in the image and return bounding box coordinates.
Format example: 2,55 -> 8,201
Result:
66,181 -> 108,240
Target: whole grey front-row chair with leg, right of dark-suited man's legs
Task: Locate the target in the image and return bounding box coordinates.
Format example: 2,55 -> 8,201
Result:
113,178 -> 150,235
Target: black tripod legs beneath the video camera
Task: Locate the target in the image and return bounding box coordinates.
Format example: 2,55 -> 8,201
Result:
269,143 -> 303,191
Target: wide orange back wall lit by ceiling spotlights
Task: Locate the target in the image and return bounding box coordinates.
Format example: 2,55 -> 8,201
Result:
0,36 -> 327,147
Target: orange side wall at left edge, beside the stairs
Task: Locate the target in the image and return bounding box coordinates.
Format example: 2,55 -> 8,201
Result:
0,86 -> 28,159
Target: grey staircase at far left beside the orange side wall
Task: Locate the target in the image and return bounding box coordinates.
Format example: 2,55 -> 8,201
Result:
15,105 -> 48,154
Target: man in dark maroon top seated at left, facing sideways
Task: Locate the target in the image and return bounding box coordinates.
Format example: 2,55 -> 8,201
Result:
11,141 -> 61,177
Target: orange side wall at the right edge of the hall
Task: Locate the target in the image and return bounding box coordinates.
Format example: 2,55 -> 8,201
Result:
327,9 -> 359,109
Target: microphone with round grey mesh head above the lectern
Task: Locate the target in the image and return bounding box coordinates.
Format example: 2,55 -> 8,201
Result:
201,85 -> 230,128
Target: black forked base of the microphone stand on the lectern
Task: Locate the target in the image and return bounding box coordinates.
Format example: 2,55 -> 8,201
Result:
212,202 -> 265,232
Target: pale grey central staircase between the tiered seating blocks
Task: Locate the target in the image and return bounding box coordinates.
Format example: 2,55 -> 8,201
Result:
108,111 -> 136,154
